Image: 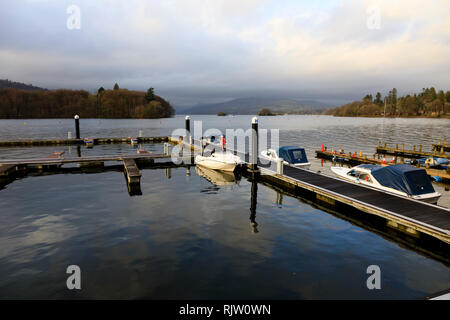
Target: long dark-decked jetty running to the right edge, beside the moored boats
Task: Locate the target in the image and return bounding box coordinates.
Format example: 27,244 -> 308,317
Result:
260,165 -> 450,244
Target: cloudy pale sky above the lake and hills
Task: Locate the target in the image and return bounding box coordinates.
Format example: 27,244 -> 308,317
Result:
0,0 -> 450,107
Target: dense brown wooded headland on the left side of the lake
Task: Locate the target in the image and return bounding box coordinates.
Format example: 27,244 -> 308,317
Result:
0,80 -> 175,119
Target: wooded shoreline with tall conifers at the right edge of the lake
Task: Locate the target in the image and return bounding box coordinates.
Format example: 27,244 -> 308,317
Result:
322,87 -> 450,118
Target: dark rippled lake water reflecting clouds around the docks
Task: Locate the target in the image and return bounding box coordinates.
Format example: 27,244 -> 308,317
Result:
0,116 -> 450,299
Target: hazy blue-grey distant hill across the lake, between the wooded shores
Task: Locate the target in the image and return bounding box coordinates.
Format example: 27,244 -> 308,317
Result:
182,98 -> 332,114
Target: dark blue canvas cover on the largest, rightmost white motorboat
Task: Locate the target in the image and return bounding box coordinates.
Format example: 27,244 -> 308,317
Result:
358,164 -> 434,195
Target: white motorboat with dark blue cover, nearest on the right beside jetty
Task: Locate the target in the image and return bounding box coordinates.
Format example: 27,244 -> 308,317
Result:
331,164 -> 441,203
